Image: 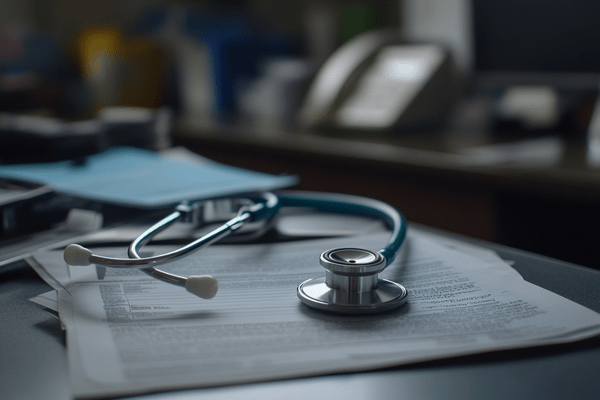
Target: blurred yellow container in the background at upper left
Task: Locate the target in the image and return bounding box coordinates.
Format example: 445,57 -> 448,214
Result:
76,28 -> 164,113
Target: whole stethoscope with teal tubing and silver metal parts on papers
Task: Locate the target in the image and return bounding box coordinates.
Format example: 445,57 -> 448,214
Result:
64,192 -> 407,314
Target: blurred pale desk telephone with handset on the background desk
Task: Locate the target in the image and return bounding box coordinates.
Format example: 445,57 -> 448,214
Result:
299,30 -> 456,131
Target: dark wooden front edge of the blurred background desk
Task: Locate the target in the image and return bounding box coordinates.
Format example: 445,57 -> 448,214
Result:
174,120 -> 600,199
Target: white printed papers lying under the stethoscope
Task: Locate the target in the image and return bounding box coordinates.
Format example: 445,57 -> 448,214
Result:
32,220 -> 600,397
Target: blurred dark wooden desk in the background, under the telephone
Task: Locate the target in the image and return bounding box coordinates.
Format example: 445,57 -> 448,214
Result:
174,120 -> 600,269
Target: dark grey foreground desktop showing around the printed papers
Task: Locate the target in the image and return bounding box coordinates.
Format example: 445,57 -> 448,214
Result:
0,225 -> 600,400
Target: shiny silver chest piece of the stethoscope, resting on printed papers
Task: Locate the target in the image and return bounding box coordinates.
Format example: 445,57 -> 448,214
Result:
298,248 -> 407,314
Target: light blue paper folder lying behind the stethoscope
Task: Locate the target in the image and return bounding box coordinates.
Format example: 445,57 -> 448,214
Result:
0,147 -> 298,208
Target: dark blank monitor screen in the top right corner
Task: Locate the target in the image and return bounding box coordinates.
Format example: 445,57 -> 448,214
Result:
471,0 -> 600,91
